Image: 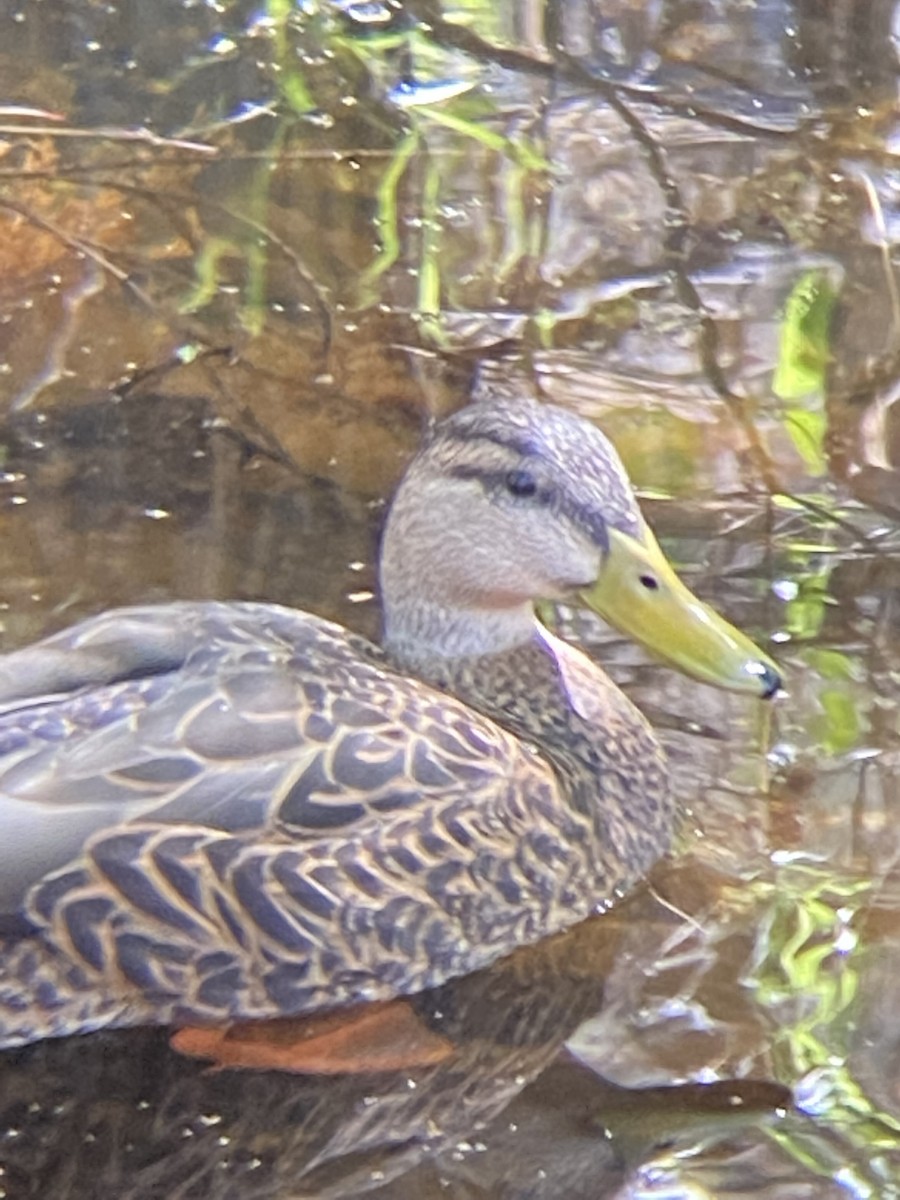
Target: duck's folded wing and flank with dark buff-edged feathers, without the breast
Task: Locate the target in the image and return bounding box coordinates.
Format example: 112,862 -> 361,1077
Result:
0,604 -> 571,1020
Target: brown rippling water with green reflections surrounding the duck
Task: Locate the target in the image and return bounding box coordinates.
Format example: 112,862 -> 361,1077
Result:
0,0 -> 900,1200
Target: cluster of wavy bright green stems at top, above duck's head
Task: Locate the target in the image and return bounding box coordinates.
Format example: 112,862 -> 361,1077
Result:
179,7 -> 550,342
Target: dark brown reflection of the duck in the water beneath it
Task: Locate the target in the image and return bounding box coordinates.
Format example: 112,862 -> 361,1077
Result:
0,899 -> 785,1200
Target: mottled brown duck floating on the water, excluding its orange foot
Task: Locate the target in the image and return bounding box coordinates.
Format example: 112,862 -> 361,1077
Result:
0,401 -> 778,1045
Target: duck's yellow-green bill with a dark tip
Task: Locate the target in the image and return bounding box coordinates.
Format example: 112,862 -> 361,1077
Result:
581,526 -> 781,698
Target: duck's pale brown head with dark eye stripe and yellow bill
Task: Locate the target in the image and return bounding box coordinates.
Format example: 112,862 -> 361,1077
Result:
382,400 -> 780,696
